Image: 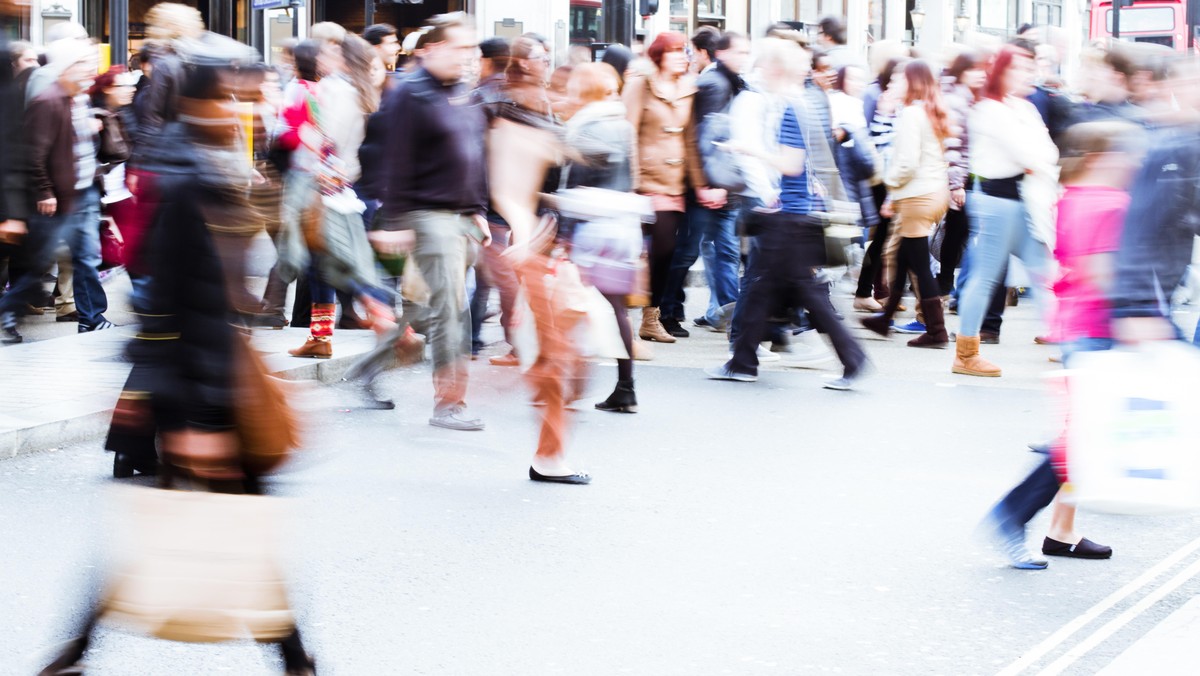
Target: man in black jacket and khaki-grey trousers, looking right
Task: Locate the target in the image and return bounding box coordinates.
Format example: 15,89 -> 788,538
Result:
383,14 -> 491,430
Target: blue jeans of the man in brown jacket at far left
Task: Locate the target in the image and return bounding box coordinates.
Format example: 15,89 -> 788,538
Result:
0,187 -> 108,327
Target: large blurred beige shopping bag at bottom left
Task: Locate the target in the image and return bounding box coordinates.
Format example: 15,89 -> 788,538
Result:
101,486 -> 295,642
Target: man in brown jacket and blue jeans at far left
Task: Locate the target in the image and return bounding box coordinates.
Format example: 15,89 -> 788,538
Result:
0,40 -> 113,343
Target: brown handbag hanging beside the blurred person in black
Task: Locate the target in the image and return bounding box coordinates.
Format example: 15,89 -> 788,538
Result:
233,336 -> 300,474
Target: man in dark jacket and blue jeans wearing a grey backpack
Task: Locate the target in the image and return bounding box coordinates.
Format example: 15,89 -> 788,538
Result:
661,32 -> 750,337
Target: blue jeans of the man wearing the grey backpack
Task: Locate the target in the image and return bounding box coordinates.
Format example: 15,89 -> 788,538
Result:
660,198 -> 742,323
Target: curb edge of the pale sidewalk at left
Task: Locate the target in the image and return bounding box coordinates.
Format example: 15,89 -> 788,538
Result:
0,331 -> 374,461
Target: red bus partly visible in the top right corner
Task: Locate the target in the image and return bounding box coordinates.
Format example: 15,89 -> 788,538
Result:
1088,0 -> 1200,52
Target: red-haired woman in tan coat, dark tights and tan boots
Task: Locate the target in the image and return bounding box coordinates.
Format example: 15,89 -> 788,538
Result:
623,32 -> 725,342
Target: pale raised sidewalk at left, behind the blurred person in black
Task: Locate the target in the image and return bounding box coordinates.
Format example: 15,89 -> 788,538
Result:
0,328 -> 374,459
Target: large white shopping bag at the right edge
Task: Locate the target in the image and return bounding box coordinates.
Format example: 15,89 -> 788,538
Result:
1064,341 -> 1200,514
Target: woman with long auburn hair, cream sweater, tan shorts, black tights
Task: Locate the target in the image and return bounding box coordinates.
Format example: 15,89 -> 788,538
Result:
863,60 -> 950,347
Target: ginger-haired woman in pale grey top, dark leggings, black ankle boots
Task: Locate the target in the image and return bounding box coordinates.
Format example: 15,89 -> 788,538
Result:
565,64 -> 637,413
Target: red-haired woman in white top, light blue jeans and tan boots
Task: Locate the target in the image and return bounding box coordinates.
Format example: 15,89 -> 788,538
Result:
950,46 -> 1058,377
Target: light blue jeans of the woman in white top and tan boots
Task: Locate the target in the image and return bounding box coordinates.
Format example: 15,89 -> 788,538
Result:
959,190 -> 1050,336
